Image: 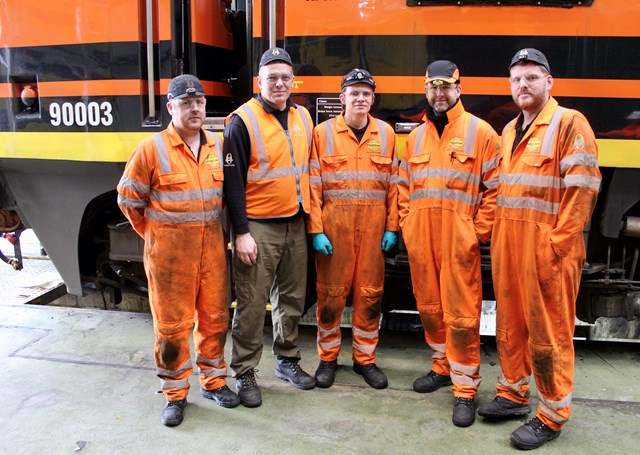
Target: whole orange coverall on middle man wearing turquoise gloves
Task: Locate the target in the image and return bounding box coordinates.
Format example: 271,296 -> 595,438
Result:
307,114 -> 399,365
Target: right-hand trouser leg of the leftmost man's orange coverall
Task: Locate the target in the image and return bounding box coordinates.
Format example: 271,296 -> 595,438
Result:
193,223 -> 229,390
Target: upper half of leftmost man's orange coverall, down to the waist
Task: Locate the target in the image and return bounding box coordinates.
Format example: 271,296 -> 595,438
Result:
118,124 -> 224,235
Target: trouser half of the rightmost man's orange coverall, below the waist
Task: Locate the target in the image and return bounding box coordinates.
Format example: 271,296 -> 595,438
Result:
494,220 -> 584,430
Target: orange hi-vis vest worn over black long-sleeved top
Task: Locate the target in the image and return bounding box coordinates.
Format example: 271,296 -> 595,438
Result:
226,98 -> 313,219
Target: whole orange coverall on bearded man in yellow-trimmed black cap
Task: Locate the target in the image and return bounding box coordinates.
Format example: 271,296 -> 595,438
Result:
398,101 -> 499,398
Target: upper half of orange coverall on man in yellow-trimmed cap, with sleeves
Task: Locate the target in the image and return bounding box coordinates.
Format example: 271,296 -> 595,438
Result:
398,101 -> 498,242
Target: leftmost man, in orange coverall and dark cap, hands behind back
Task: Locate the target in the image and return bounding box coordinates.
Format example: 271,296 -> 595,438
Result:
118,74 -> 240,426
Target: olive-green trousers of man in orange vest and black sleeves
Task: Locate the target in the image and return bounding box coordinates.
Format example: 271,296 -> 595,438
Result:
230,216 -> 307,377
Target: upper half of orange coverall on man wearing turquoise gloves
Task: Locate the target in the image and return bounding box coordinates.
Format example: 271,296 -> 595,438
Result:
307,114 -> 400,235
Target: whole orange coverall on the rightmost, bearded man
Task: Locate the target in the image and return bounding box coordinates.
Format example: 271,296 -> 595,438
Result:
491,98 -> 601,431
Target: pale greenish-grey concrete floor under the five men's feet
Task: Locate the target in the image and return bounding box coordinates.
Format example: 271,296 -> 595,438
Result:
0,303 -> 640,455
